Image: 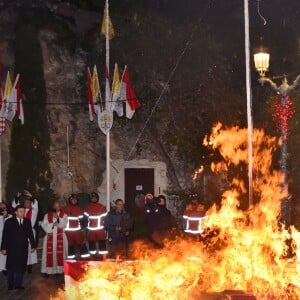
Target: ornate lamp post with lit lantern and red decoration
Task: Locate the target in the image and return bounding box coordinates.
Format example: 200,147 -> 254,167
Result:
254,52 -> 300,226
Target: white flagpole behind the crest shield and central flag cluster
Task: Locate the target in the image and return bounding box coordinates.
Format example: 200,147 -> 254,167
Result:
105,0 -> 110,211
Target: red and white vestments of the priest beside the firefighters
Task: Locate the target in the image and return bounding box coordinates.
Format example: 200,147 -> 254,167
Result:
41,211 -> 68,274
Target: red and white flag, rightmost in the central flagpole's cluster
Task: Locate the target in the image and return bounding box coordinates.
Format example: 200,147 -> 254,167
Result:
120,66 -> 141,119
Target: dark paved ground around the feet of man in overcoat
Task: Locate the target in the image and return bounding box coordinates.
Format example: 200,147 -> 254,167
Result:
0,247 -> 64,300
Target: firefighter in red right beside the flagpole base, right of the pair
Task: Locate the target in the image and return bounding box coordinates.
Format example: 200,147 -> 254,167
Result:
84,193 -> 108,260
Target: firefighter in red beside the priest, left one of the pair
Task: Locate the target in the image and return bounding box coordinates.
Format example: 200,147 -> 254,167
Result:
63,194 -> 90,259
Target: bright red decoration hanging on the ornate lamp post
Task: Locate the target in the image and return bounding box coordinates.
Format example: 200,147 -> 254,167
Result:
272,96 -> 296,138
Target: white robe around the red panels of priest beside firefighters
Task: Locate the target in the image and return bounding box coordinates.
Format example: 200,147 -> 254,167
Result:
41,214 -> 68,274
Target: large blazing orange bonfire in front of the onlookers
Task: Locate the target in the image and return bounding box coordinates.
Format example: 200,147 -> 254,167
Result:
53,124 -> 300,300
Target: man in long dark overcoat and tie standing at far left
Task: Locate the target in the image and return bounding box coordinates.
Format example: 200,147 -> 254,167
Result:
1,205 -> 35,290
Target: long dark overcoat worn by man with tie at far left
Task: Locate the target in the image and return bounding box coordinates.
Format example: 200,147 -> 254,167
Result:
1,216 -> 35,271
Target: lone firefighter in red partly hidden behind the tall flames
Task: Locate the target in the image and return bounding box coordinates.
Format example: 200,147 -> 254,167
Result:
183,195 -> 206,235
